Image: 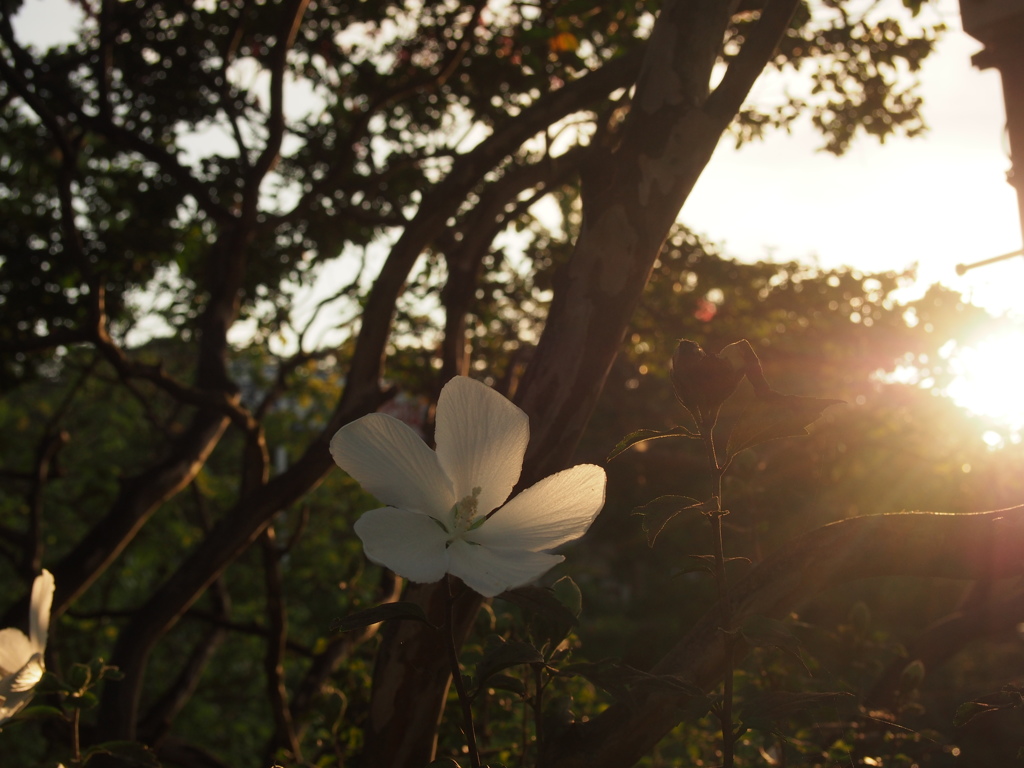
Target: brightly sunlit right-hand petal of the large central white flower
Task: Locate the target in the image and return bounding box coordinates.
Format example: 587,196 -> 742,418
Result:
466,464 -> 606,552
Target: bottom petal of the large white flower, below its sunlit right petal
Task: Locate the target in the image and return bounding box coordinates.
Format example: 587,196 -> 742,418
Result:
449,540 -> 565,597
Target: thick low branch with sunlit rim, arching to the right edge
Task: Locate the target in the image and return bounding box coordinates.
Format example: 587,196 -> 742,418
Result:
544,507 -> 1024,768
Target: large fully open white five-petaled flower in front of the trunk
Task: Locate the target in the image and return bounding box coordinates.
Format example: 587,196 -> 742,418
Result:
331,377 -> 605,597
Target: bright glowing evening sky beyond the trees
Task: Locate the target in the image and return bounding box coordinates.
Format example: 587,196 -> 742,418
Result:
14,0 -> 1024,429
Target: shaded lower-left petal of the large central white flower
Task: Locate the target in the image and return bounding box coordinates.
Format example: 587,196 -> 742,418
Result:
353,507 -> 449,583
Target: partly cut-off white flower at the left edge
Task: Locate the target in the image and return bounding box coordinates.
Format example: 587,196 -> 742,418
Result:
0,570 -> 53,723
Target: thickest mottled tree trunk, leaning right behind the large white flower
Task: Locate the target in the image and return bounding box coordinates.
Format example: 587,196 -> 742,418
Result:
366,0 -> 796,768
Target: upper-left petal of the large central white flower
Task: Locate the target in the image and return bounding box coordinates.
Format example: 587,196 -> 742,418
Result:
331,414 -> 458,521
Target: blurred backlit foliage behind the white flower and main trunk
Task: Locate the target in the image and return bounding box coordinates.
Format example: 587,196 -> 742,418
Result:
0,0 -> 1024,766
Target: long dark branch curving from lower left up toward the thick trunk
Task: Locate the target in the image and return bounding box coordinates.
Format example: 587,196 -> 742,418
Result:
94,46 -> 638,739
